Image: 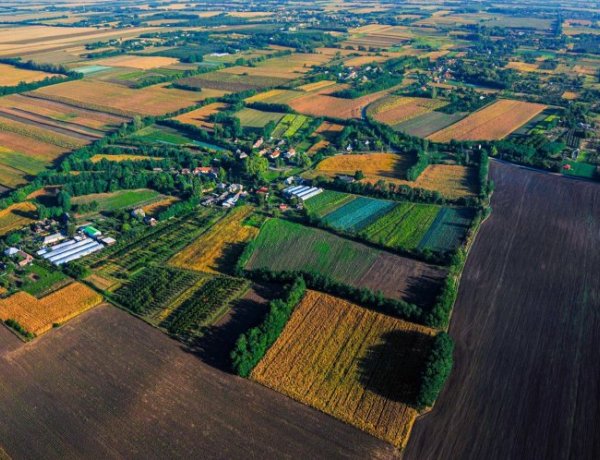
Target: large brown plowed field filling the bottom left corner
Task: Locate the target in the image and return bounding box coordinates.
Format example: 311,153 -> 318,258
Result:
0,307 -> 393,459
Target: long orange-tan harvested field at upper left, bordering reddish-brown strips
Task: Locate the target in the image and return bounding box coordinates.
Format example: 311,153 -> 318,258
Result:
30,80 -> 206,116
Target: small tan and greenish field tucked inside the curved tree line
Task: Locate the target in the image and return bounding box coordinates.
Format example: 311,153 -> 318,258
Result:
367,96 -> 446,128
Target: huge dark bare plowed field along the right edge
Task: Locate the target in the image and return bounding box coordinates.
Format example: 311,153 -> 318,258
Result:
404,162 -> 600,460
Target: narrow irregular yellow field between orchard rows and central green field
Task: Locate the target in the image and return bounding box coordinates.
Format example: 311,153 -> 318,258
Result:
170,206 -> 258,273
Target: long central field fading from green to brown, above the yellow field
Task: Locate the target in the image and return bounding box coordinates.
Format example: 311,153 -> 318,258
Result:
245,219 -> 444,304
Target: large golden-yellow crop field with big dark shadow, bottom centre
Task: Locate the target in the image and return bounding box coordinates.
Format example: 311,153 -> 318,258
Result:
251,291 -> 434,447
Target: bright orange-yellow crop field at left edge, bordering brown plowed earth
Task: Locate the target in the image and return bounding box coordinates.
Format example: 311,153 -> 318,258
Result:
0,282 -> 102,335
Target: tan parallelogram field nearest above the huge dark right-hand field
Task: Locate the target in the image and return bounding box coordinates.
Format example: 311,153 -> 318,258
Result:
428,99 -> 546,142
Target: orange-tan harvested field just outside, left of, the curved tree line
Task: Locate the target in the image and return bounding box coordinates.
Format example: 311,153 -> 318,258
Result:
289,90 -> 388,120
